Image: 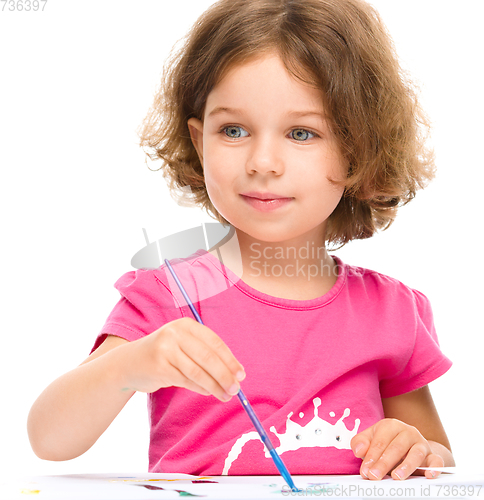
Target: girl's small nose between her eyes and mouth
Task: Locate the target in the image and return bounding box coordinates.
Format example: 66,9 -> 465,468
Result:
246,134 -> 284,175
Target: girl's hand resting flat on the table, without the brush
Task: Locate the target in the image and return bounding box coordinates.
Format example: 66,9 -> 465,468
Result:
351,418 -> 444,480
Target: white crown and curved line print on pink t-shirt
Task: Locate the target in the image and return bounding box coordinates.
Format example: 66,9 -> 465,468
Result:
222,398 -> 360,475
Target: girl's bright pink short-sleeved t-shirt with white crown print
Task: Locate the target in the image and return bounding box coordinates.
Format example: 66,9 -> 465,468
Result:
93,250 -> 451,475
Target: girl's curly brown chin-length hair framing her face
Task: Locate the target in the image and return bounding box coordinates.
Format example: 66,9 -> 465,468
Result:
139,0 -> 434,245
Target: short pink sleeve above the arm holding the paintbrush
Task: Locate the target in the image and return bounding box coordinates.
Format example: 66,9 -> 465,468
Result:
91,269 -> 183,352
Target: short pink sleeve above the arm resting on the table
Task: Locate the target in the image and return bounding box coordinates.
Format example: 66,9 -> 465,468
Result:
380,290 -> 452,398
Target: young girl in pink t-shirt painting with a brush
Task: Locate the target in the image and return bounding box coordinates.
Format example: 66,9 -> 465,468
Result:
28,0 -> 454,480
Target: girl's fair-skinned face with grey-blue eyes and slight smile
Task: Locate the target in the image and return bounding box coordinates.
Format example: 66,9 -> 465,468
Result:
188,54 -> 346,244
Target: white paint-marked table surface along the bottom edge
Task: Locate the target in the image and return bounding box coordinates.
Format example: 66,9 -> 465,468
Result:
0,472 -> 484,500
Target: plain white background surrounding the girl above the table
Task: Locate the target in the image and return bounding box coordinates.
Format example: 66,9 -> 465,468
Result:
0,0 -> 484,475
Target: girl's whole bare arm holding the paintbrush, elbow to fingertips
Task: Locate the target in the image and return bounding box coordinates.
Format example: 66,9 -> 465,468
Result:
27,318 -> 245,460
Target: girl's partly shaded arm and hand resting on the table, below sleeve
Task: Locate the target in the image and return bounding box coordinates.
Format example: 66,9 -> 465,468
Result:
351,386 -> 455,480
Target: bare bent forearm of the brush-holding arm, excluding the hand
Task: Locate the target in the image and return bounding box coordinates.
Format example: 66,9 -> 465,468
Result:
27,335 -> 134,460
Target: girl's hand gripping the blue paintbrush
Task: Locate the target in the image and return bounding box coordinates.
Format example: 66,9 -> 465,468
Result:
124,318 -> 245,401
